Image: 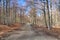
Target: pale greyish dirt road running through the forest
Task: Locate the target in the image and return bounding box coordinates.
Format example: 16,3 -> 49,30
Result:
1,25 -> 58,40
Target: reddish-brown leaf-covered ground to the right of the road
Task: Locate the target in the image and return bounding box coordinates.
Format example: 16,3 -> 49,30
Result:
34,25 -> 60,38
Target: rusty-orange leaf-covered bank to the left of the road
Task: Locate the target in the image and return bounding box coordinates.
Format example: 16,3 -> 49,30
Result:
0,23 -> 22,37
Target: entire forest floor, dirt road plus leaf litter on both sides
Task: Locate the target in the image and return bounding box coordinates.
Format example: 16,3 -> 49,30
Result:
0,23 -> 60,40
